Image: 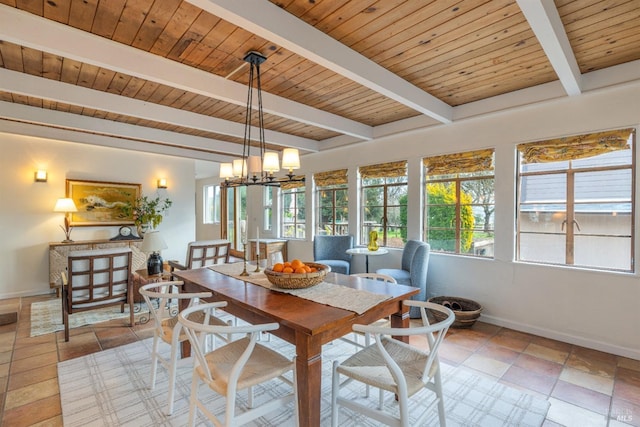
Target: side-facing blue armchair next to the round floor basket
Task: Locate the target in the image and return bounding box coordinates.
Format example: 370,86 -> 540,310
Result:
376,240 -> 431,318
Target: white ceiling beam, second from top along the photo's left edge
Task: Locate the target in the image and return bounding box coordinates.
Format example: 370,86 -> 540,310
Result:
0,69 -> 319,154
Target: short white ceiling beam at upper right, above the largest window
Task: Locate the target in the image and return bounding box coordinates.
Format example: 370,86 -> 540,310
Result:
516,0 -> 582,96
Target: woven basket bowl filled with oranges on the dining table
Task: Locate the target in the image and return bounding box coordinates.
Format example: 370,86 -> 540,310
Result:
264,259 -> 331,289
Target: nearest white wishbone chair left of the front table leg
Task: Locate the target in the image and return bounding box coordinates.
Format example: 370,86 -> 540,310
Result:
178,301 -> 299,426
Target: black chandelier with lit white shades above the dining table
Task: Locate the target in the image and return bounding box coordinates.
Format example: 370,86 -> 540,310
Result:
220,52 -> 304,187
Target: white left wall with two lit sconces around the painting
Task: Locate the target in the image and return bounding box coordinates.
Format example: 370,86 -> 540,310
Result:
0,132 -> 195,298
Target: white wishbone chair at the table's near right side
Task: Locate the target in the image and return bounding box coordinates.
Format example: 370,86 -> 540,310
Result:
331,300 -> 455,427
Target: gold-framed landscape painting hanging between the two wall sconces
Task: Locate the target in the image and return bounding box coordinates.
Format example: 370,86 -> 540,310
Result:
66,179 -> 142,227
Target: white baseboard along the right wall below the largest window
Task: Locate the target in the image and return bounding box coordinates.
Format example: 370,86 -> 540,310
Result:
478,314 -> 640,360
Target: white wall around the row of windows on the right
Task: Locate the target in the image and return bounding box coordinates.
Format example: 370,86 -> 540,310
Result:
290,83 -> 640,359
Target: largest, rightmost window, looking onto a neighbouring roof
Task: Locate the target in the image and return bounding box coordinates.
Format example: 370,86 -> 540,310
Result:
517,129 -> 635,271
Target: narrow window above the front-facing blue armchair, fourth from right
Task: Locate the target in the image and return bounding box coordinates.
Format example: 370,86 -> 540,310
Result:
313,169 -> 349,235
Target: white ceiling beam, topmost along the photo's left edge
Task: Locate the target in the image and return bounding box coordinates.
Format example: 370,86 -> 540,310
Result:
0,5 -> 372,139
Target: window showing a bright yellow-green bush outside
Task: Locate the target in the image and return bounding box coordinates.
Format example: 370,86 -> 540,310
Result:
423,149 -> 495,257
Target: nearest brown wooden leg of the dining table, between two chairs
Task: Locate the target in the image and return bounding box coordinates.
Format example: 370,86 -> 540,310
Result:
296,333 -> 322,427
